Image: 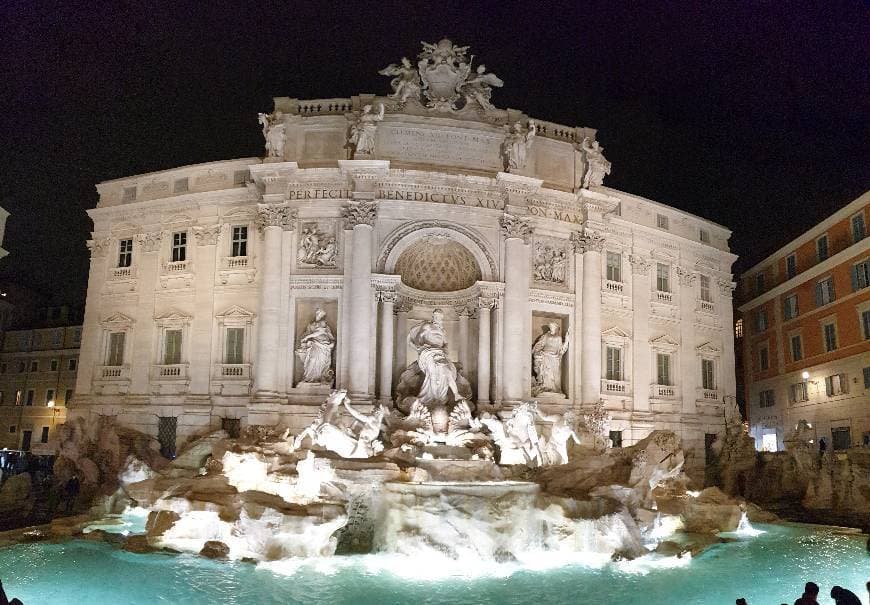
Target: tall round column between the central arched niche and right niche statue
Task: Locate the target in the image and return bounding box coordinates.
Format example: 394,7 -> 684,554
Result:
501,213 -> 532,401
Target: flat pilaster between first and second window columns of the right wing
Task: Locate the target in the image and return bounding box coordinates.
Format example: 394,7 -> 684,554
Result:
628,254 -> 652,412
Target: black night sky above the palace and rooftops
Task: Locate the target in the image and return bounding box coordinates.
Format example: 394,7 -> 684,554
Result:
0,0 -> 870,302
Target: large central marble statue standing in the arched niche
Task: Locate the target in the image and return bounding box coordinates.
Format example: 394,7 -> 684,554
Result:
408,309 -> 462,405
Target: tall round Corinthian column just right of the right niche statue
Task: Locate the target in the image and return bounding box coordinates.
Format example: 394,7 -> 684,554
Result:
571,229 -> 604,403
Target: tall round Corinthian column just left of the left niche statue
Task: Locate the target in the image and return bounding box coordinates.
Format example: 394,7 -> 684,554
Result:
254,204 -> 296,398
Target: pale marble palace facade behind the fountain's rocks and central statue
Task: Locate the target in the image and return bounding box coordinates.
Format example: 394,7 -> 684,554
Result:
76,43 -> 735,470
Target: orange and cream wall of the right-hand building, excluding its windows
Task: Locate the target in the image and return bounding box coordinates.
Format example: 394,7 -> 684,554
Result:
739,193 -> 870,448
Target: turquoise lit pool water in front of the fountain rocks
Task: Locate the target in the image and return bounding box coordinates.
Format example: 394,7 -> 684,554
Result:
0,525 -> 870,605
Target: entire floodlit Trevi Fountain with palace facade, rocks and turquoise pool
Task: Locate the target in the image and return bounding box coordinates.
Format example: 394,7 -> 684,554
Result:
0,40 -> 868,604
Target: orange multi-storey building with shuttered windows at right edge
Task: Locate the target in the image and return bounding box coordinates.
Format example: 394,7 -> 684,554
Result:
738,191 -> 870,450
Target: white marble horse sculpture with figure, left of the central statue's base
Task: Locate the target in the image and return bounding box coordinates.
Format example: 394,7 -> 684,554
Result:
291,389 -> 387,458
